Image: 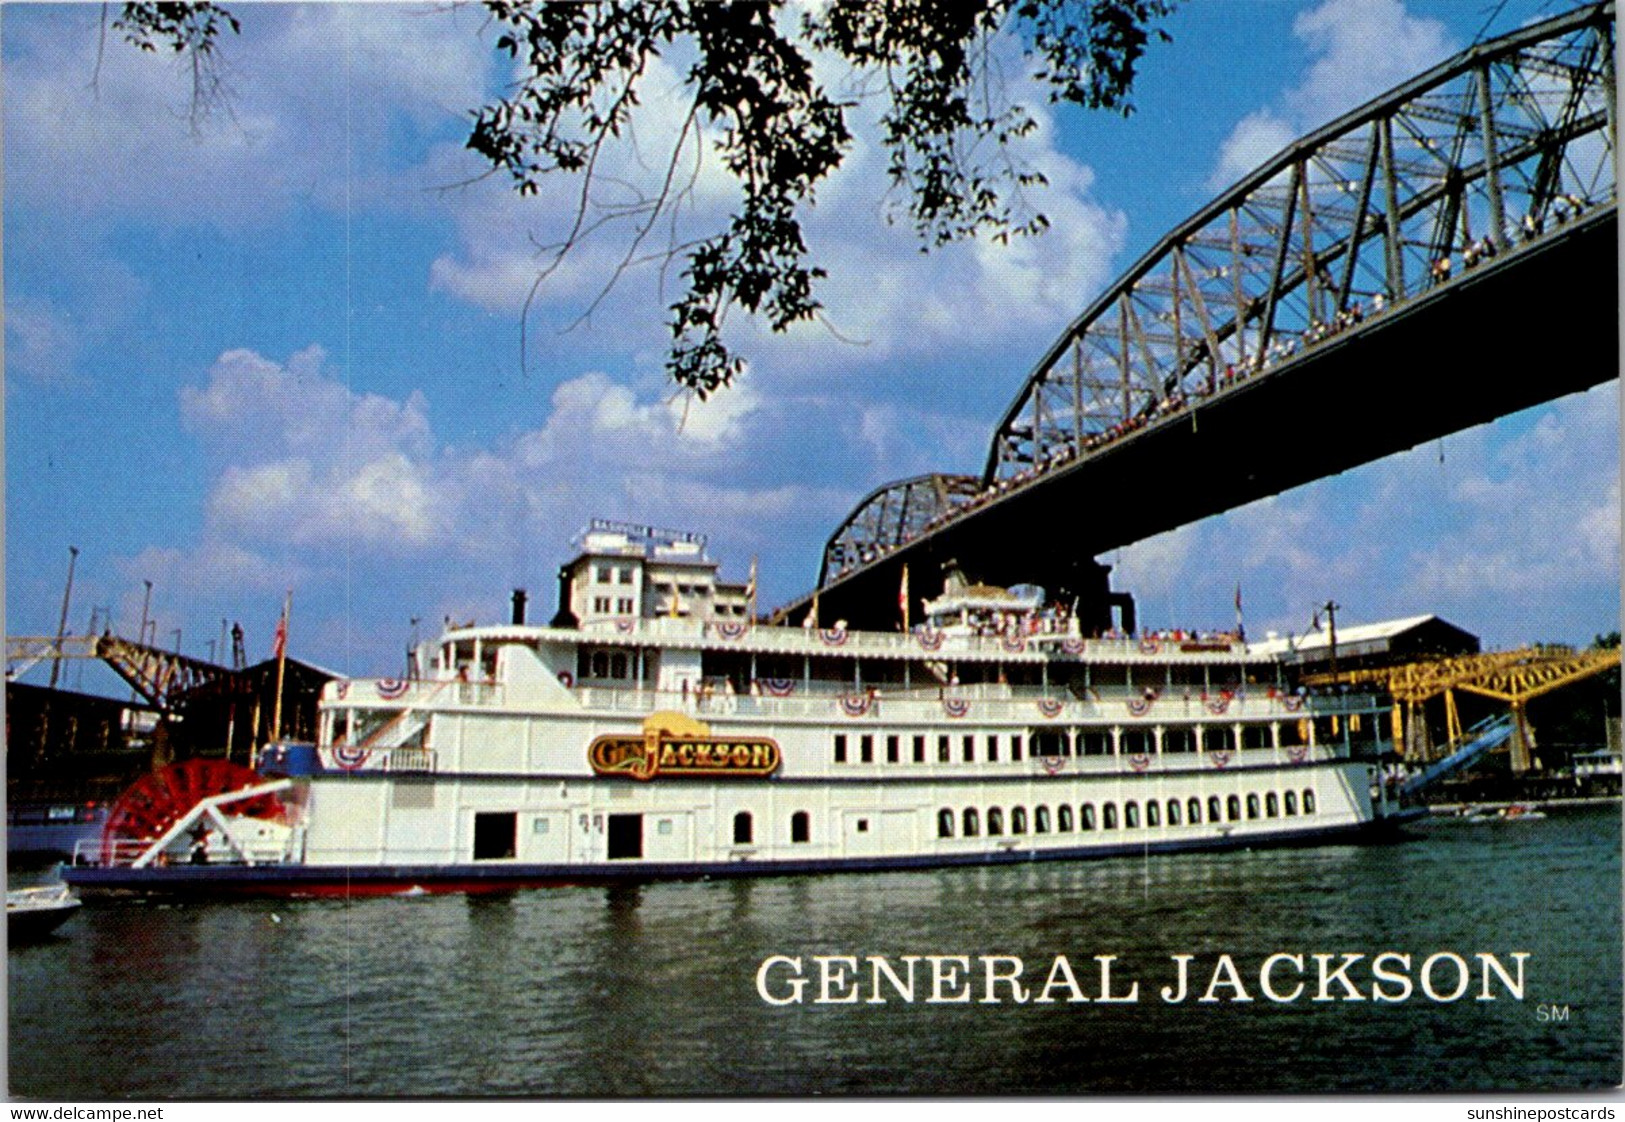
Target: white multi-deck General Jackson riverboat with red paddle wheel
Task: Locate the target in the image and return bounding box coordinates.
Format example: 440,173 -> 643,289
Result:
63,524 -> 1398,894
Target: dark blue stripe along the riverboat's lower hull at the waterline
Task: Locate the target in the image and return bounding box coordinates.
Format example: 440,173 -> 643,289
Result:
62,816 -> 1409,893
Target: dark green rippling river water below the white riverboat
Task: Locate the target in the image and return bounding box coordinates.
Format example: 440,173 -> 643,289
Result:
8,803 -> 1622,1101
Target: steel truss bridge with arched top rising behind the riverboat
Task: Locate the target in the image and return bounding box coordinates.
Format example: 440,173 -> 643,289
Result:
775,0 -> 1619,628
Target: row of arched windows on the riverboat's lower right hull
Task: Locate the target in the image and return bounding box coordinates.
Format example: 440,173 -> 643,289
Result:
936,789 -> 1315,837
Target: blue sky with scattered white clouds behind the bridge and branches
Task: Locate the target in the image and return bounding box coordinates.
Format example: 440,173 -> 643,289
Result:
0,0 -> 1620,673
